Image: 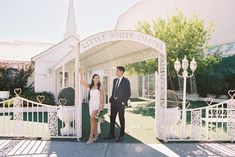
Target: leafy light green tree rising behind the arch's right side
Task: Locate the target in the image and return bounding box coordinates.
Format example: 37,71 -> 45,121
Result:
127,11 -> 217,89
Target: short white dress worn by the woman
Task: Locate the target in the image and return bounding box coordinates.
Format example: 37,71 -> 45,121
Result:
89,89 -> 101,134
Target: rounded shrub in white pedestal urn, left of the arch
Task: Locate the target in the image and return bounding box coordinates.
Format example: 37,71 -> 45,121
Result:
57,87 -> 75,135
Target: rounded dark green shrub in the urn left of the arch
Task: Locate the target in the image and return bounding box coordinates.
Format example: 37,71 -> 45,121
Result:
58,87 -> 75,106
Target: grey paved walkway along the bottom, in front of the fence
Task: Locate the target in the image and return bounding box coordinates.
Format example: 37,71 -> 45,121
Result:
0,139 -> 235,157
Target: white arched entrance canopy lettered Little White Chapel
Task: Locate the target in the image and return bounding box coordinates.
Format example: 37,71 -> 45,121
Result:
75,31 -> 167,140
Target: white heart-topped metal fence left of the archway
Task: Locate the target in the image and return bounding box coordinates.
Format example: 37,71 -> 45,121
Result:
0,89 -> 80,139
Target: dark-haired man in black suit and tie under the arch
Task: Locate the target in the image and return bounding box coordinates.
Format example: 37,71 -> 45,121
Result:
108,66 -> 131,142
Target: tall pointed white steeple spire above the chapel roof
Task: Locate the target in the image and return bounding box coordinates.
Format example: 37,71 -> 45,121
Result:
64,0 -> 79,39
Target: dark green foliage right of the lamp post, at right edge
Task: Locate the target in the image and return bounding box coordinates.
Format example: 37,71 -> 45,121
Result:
196,56 -> 235,96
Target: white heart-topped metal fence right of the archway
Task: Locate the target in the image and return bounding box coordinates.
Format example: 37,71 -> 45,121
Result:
165,90 -> 235,142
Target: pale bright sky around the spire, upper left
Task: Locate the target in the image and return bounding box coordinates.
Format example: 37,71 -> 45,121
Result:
0,0 -> 139,43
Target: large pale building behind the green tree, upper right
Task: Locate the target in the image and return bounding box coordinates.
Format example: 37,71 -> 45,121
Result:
115,0 -> 235,57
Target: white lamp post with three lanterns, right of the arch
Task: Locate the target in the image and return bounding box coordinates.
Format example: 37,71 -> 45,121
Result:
174,56 -> 197,138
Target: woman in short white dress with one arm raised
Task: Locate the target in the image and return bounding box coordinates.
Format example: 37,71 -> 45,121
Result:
80,70 -> 104,144
